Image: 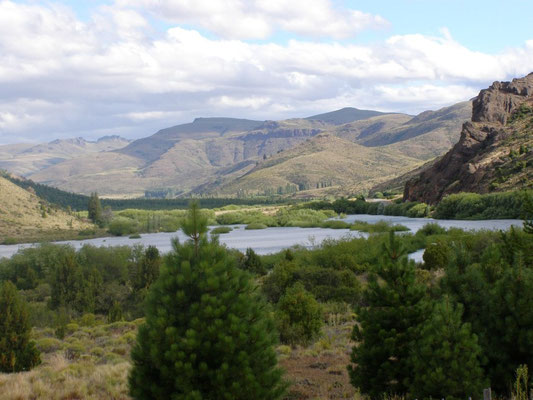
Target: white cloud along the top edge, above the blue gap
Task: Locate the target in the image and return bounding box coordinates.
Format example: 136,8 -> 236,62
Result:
117,0 -> 388,39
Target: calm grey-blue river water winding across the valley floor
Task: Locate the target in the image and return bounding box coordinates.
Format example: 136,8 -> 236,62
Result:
0,214 -> 522,261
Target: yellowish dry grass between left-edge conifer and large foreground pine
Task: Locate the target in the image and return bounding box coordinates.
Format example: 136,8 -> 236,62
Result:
0,320 -> 142,400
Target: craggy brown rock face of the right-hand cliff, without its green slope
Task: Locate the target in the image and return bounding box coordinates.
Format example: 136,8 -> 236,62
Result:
404,73 -> 533,204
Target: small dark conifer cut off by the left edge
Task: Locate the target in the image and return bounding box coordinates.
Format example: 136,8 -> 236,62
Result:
0,281 -> 41,372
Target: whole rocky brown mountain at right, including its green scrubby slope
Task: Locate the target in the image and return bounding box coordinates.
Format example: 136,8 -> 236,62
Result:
404,73 -> 533,204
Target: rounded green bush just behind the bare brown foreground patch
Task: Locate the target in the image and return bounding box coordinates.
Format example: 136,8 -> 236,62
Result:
276,283 -> 323,345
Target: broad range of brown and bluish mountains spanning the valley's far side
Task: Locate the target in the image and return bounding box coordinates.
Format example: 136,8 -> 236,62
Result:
4,102 -> 469,197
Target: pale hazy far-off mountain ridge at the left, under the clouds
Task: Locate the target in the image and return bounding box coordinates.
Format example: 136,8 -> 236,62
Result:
0,136 -> 130,176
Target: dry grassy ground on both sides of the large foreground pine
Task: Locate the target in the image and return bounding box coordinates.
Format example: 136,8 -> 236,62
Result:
0,312 -> 359,400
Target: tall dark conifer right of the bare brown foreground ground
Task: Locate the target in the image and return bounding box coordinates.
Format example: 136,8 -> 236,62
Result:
348,234 -> 428,398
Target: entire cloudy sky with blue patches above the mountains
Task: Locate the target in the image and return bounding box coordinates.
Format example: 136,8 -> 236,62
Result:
0,0 -> 533,144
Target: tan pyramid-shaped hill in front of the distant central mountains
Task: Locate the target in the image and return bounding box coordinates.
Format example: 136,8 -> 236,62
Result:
204,134 -> 418,195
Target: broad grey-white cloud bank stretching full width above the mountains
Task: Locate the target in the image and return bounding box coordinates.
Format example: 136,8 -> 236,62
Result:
0,0 -> 533,143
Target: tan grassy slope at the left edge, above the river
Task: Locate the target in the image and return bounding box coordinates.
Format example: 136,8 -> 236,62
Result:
0,177 -> 94,243
